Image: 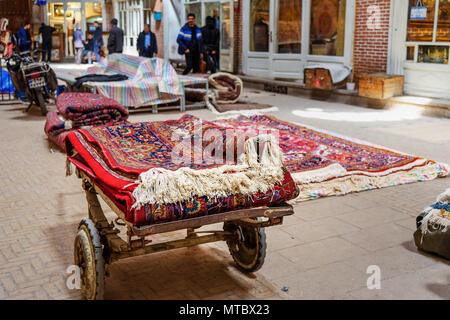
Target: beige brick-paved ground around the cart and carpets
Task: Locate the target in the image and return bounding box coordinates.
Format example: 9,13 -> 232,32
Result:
0,86 -> 450,299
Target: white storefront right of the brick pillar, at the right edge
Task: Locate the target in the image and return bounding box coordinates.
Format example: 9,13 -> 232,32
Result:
390,0 -> 450,99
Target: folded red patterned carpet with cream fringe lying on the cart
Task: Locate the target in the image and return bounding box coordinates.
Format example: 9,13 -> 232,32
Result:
66,117 -> 298,226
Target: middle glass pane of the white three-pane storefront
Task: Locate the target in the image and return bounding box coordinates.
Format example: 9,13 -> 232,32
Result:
276,0 -> 302,53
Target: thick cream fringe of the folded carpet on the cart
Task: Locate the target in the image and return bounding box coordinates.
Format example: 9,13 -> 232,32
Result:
133,135 -> 284,209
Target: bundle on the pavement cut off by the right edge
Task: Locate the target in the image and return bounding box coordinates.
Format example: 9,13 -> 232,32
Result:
414,189 -> 450,259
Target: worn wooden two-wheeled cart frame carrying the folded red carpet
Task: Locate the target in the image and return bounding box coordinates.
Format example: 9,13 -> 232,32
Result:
74,169 -> 294,300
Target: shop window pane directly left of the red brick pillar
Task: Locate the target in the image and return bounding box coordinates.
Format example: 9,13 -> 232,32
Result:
310,0 -> 346,56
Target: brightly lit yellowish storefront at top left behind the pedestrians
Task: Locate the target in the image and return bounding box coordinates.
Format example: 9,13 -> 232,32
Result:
45,0 -> 106,56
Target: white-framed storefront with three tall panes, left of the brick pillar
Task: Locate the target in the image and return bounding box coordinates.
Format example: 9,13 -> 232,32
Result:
242,0 -> 355,79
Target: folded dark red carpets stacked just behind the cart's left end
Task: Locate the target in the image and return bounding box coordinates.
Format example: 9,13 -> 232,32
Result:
44,92 -> 128,149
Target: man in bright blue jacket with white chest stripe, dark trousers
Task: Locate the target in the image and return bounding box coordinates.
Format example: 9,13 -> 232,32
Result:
177,13 -> 203,75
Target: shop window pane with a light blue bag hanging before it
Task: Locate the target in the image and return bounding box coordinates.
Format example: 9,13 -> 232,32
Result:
406,0 -> 436,41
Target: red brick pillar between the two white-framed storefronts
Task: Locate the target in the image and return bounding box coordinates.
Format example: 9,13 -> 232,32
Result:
354,0 -> 390,77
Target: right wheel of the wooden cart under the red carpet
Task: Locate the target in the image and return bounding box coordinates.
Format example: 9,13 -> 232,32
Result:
223,218 -> 267,272
